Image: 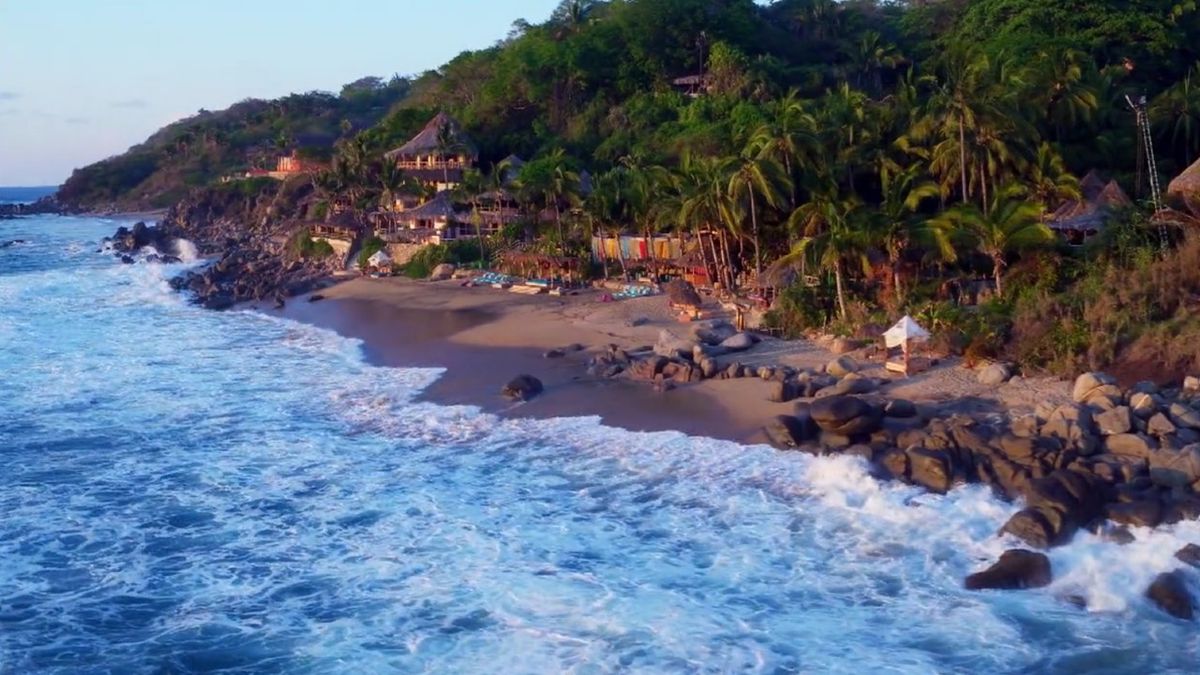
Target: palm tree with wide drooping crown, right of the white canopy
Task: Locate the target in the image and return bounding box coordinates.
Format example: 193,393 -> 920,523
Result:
938,185 -> 1054,298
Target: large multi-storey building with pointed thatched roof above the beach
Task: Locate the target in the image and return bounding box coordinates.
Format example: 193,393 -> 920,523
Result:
384,113 -> 479,192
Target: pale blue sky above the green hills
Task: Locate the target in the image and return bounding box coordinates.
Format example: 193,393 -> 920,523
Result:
0,0 -> 559,185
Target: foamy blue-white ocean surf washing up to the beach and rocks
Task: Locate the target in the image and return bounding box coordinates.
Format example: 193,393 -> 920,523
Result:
0,212 -> 1200,674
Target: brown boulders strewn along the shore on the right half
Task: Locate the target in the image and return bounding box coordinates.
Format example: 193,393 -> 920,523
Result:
523,322 -> 1200,619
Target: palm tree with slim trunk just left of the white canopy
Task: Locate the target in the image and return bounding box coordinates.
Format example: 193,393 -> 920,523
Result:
781,185 -> 869,319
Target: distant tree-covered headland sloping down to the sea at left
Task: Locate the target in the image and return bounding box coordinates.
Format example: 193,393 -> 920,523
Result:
58,77 -> 409,209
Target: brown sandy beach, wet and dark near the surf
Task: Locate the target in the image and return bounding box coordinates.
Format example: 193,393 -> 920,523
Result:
262,277 -> 1070,442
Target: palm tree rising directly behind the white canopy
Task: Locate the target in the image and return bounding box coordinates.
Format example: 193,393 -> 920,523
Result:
872,165 -> 954,300
